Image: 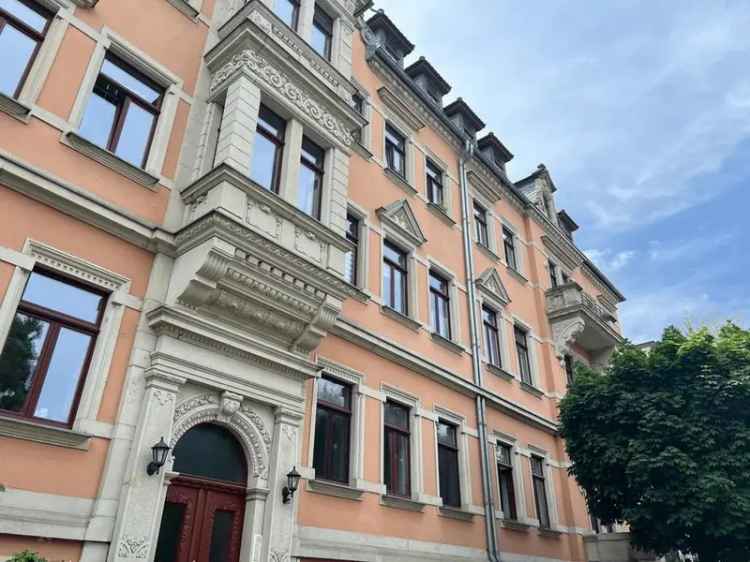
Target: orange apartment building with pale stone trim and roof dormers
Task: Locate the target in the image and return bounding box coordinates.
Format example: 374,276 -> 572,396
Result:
0,0 -> 623,562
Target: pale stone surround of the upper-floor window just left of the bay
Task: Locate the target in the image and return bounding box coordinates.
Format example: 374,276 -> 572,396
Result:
67,28 -> 188,185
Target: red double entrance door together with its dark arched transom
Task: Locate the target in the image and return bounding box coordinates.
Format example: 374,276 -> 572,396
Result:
155,423 -> 247,562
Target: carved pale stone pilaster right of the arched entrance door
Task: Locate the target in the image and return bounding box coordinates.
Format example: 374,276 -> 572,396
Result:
262,407 -> 303,562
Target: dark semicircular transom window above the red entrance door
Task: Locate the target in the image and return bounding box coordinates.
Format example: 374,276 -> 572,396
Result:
174,423 -> 247,486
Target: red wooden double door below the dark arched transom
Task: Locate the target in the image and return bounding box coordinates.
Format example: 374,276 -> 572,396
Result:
155,477 -> 245,562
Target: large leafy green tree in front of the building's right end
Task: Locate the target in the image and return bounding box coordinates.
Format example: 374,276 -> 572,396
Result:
560,323 -> 750,562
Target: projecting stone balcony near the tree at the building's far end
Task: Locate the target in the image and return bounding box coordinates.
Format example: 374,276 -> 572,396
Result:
546,282 -> 622,367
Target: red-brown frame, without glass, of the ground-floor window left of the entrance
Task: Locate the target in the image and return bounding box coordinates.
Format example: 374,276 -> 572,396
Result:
0,268 -> 109,428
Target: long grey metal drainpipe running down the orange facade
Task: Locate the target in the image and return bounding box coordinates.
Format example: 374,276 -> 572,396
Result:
458,140 -> 502,562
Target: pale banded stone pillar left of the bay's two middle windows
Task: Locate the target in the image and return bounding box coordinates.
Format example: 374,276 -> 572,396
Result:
216,74 -> 260,174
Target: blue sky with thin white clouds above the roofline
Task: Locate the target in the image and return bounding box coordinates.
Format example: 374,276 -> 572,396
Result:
376,0 -> 750,341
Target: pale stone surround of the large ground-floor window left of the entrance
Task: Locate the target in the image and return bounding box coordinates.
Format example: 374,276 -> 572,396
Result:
0,239 -> 133,437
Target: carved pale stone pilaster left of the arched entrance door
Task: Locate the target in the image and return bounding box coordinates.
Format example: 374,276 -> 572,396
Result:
108,369 -> 185,562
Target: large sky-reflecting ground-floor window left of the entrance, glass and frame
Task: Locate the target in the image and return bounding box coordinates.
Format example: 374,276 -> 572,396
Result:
0,271 -> 107,426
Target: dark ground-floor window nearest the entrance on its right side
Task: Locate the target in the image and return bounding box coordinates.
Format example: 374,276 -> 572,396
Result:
313,377 -> 352,484
